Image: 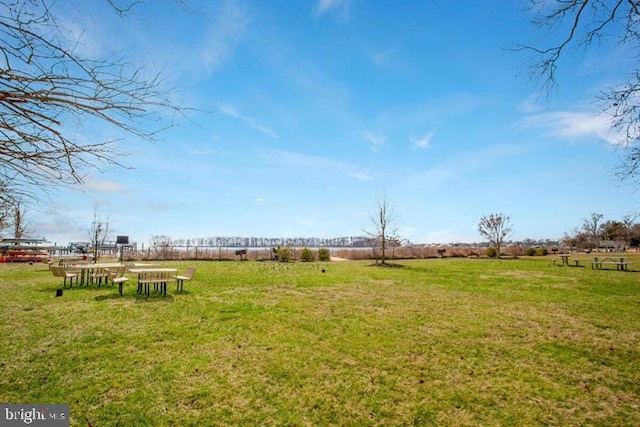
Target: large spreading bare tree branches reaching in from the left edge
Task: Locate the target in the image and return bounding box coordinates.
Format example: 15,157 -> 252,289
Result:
0,0 -> 180,199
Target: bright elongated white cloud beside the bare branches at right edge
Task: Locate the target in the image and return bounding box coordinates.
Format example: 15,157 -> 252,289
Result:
520,111 -> 621,144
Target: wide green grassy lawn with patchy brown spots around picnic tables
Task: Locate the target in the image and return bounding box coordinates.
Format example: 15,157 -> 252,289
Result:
0,256 -> 640,427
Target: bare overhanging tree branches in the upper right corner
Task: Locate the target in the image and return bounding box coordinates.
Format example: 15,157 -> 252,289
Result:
519,0 -> 640,185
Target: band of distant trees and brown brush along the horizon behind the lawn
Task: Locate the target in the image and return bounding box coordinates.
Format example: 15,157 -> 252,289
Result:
125,209 -> 640,261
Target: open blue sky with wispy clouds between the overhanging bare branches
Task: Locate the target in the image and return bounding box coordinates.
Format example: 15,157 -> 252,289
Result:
30,0 -> 638,244
